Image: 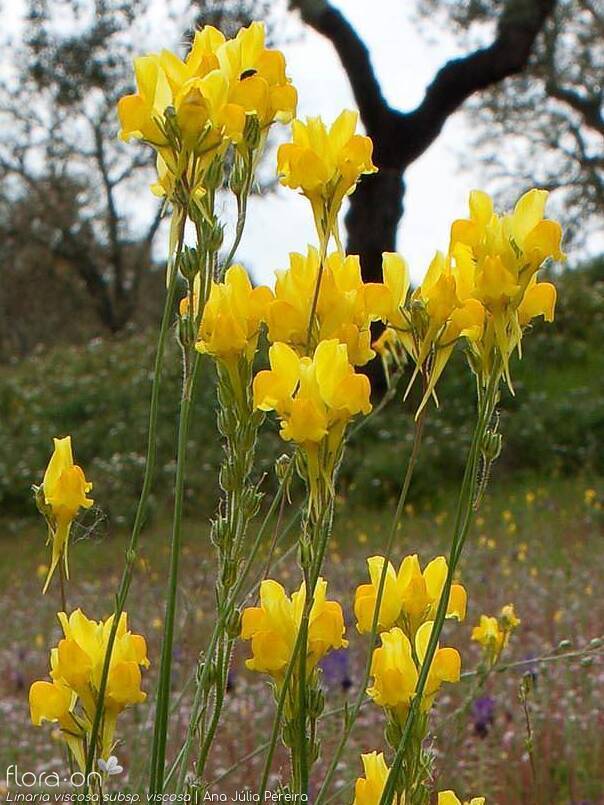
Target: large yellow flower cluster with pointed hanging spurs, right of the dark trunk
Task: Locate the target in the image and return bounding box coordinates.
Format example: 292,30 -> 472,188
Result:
376,190 -> 564,413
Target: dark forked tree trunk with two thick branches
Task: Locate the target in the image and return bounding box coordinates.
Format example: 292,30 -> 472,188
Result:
289,0 -> 556,279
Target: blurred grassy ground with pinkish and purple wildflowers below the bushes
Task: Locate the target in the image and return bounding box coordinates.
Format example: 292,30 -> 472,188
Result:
0,476 -> 604,805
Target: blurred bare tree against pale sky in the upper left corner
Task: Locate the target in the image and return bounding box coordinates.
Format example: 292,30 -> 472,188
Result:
0,0 -> 266,351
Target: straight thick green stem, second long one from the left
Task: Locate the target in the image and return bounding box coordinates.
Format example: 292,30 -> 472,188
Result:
149,352 -> 201,794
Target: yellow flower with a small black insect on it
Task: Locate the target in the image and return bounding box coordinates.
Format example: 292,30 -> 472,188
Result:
218,22 -> 298,128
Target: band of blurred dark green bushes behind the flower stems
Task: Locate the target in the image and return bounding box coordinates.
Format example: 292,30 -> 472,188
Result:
0,260 -> 604,525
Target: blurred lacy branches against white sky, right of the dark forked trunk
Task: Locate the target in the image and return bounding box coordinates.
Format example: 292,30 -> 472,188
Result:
428,0 -> 604,238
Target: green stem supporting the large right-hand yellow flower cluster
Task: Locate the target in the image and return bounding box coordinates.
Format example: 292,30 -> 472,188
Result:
379,368 -> 499,805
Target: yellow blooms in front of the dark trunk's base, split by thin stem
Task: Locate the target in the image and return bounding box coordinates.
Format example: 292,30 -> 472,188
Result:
268,246 -> 389,366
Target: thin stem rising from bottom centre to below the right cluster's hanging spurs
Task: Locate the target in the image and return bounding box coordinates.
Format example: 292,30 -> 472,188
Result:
316,409 -> 426,805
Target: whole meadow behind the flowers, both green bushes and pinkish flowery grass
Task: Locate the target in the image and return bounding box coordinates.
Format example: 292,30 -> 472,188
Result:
0,264 -> 604,805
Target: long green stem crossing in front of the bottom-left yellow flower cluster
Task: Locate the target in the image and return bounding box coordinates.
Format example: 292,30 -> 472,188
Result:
84,221 -> 184,794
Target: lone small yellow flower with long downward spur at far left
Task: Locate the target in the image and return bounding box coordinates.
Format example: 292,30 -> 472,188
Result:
40,436 -> 94,592
